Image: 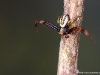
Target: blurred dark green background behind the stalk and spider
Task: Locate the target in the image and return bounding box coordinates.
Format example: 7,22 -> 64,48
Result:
0,0 -> 100,75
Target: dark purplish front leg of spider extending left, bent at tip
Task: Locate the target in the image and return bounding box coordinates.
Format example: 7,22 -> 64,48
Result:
35,20 -> 60,32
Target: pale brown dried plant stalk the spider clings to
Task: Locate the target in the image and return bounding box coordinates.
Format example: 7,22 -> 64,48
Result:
57,0 -> 84,75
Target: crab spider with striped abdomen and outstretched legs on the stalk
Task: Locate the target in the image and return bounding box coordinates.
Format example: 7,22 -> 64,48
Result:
35,14 -> 94,42
